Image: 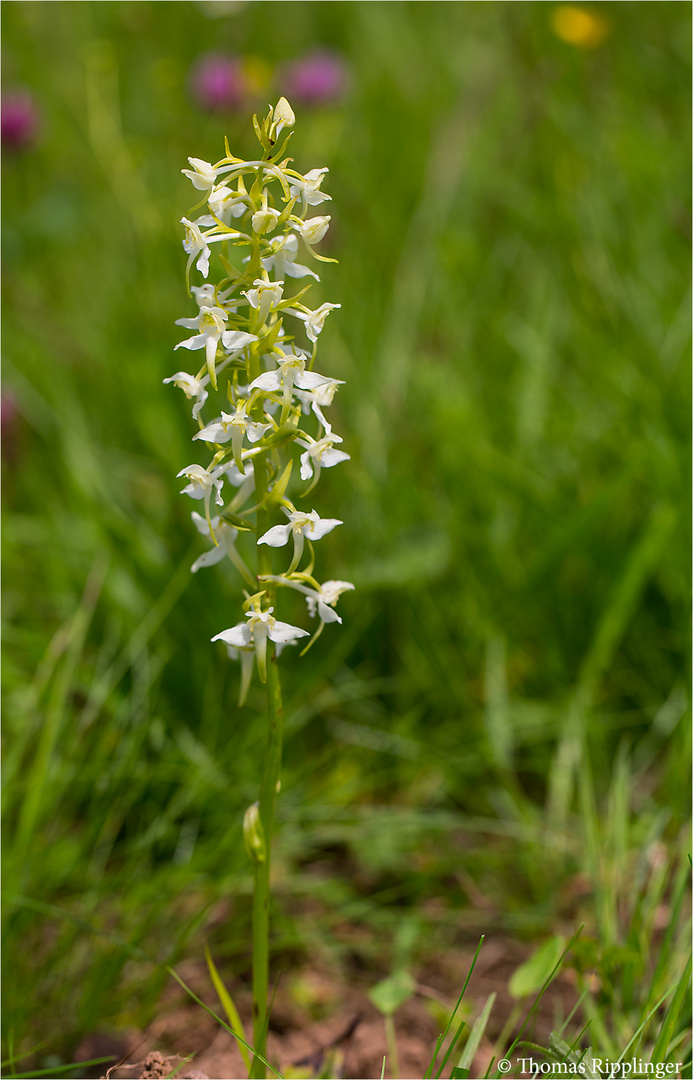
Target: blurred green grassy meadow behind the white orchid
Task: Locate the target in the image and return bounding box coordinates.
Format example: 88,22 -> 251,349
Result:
2,0 -> 691,1055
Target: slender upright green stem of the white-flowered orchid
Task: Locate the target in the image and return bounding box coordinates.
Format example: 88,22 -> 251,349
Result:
250,442 -> 284,1080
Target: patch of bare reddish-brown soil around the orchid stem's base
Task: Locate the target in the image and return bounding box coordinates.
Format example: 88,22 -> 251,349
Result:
82,939 -> 575,1080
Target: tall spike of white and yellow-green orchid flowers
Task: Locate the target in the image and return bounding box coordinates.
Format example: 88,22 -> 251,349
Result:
164,98 -> 354,708
